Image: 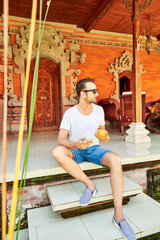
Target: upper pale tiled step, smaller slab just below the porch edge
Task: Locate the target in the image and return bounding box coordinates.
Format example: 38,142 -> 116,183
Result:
47,177 -> 142,211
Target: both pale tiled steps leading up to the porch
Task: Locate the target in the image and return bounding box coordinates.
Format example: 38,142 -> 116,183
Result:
27,177 -> 160,240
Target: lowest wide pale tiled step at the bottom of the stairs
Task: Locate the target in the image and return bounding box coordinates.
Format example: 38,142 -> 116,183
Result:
27,193 -> 160,240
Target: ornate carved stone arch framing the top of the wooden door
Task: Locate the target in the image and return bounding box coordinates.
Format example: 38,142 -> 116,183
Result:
13,25 -> 86,105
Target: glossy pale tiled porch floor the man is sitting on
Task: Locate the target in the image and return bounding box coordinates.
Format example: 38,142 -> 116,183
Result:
0,129 -> 160,182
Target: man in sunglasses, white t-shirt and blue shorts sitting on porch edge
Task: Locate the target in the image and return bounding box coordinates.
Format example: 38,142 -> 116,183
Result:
52,78 -> 135,240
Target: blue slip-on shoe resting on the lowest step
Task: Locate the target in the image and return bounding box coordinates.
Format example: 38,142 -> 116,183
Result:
112,217 -> 136,240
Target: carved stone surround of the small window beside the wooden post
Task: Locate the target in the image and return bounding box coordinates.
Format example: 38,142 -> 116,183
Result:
108,51 -> 145,99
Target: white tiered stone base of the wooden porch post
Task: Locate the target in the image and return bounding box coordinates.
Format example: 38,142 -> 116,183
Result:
125,123 -> 151,143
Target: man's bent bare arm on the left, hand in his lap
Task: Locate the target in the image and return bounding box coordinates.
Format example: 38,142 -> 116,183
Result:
57,129 -> 93,149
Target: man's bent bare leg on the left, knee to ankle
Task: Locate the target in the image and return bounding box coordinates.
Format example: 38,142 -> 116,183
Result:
52,146 -> 95,191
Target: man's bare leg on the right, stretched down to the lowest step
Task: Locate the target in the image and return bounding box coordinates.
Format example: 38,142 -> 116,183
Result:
102,152 -> 124,222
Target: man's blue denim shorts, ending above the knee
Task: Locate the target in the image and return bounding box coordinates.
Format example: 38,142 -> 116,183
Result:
70,145 -> 111,166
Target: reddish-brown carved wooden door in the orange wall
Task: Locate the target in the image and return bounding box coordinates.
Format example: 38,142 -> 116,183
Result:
28,58 -> 60,131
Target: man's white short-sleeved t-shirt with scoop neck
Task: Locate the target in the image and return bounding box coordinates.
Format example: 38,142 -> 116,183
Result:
60,104 -> 105,146
